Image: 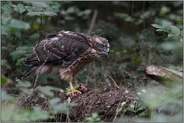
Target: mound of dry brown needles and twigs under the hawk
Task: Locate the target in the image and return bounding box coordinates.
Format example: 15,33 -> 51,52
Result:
18,86 -> 139,122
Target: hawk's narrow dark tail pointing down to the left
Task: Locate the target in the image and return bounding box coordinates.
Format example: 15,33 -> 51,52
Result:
15,65 -> 37,81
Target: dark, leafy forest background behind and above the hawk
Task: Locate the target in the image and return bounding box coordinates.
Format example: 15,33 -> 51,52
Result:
1,1 -> 183,88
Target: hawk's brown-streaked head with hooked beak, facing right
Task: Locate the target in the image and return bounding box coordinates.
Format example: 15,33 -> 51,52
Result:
93,37 -> 110,55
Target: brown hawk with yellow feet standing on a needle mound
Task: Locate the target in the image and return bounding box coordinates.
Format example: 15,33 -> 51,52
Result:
16,30 -> 110,94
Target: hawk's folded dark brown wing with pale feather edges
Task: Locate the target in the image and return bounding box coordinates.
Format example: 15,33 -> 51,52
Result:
25,31 -> 89,67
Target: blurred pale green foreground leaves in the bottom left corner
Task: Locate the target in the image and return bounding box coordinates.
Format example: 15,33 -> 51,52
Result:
1,90 -> 51,122
